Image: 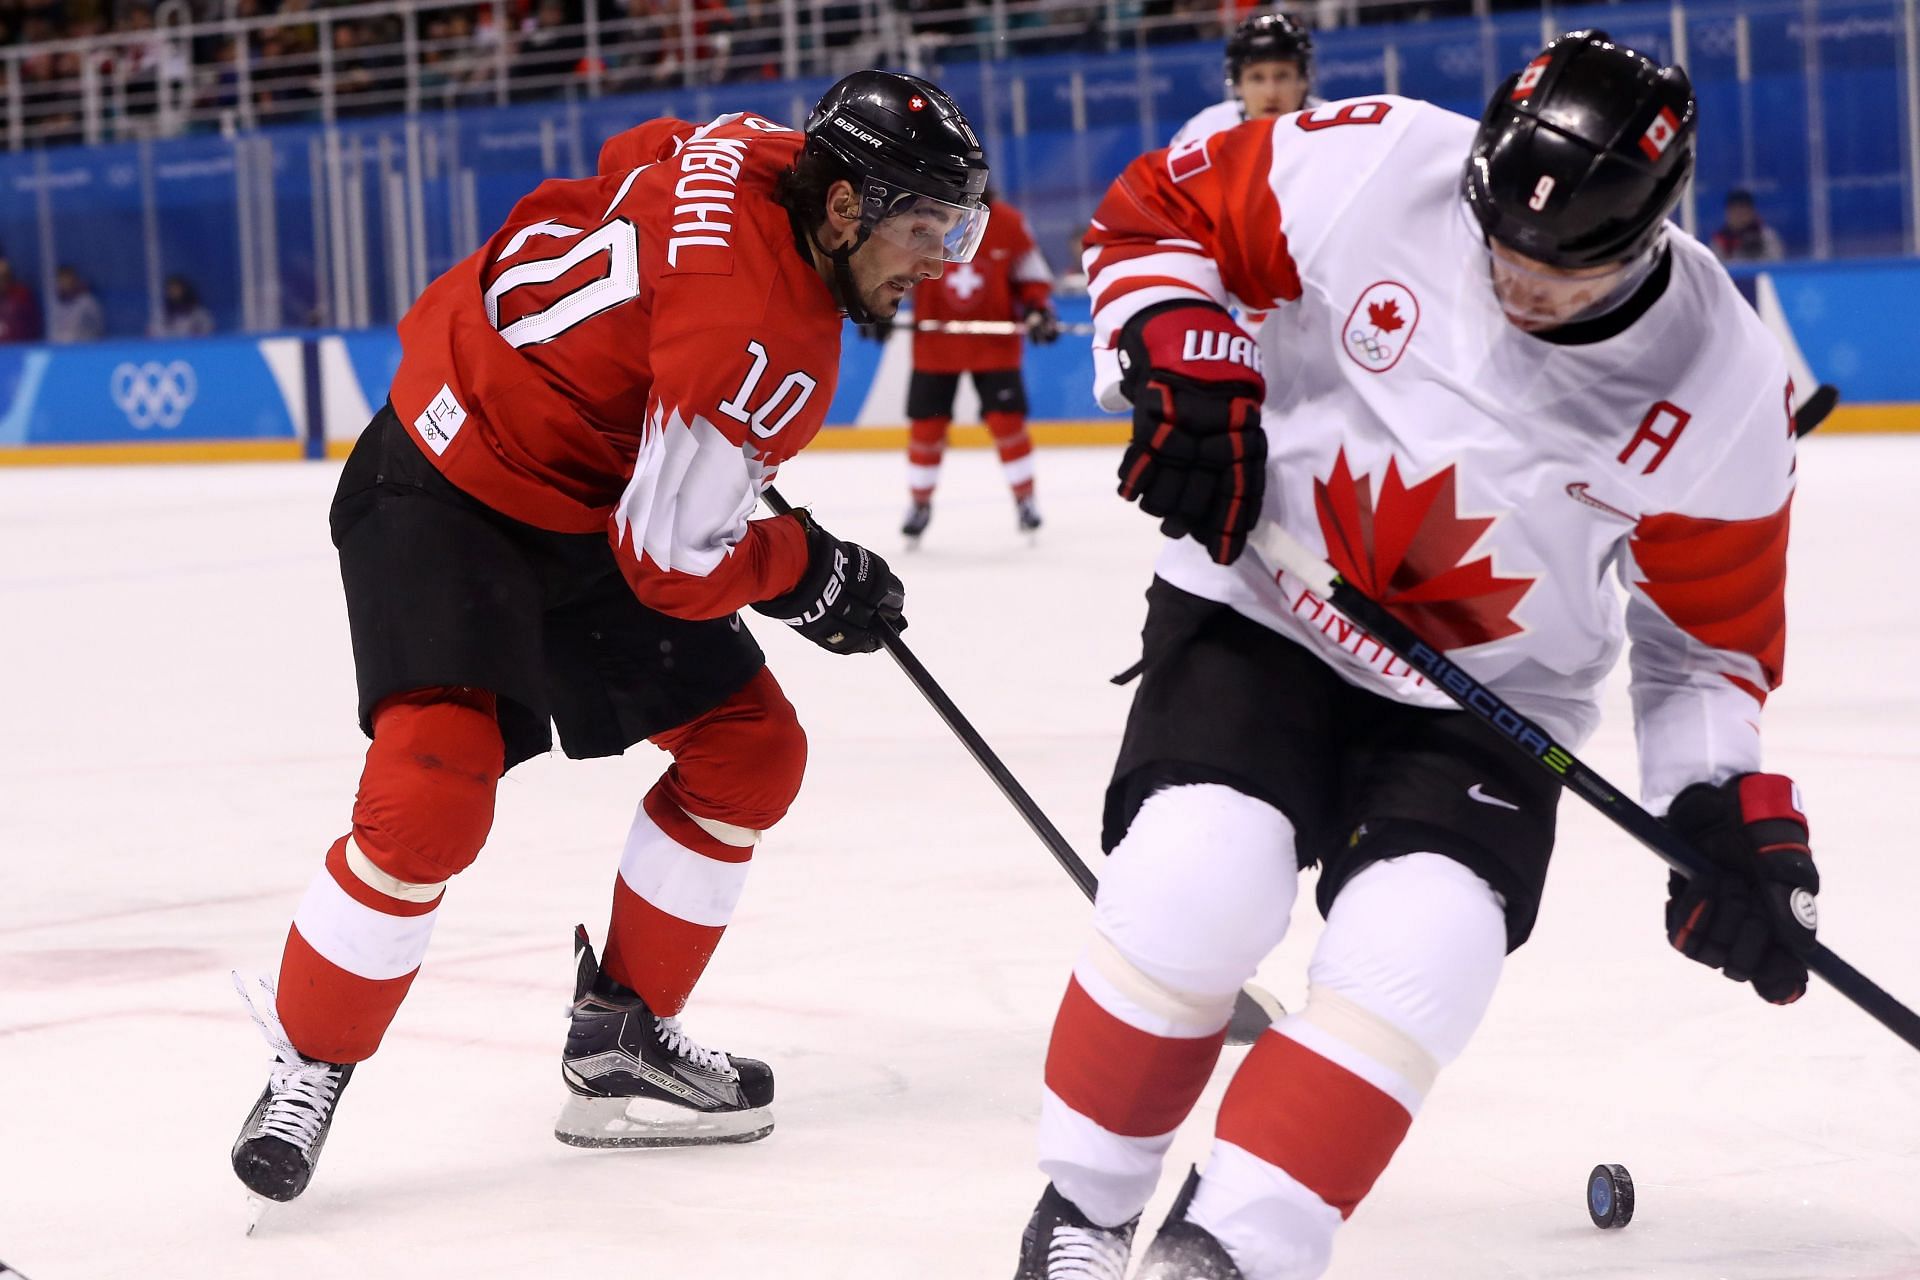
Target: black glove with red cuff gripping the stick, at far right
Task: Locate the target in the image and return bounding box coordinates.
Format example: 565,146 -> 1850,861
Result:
1667,773 -> 1820,1004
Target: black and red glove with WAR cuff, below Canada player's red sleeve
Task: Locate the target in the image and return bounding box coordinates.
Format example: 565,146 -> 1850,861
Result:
1119,301 -> 1267,564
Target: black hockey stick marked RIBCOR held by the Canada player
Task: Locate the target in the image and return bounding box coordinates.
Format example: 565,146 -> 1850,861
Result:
1250,520 -> 1920,1050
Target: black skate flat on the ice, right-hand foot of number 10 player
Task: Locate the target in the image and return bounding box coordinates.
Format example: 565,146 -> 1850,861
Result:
553,927 -> 774,1148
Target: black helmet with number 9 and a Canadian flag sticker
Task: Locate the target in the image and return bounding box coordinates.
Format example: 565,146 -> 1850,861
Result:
1461,31 -> 1695,267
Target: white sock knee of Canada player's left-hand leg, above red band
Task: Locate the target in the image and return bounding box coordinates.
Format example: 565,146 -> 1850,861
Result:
1092,783 -> 1300,998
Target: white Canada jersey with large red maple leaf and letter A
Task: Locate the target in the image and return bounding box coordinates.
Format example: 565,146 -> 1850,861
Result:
1087,98 -> 1793,812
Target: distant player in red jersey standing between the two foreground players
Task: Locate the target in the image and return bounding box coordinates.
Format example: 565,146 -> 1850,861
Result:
870,192 -> 1060,539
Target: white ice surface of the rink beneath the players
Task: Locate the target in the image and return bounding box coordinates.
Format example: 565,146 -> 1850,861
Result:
0,438 -> 1920,1280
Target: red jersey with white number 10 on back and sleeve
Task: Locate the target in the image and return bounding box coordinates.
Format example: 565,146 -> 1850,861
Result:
392,115 -> 841,618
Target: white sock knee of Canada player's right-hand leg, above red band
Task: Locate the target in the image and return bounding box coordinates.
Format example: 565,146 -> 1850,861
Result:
1288,854 -> 1507,1090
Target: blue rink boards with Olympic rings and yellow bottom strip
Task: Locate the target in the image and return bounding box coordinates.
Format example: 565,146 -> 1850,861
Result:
0,259 -> 1920,464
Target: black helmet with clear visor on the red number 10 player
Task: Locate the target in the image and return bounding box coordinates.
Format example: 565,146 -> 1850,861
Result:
806,71 -> 987,263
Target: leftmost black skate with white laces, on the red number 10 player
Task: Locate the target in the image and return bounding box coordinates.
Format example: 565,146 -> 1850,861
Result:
232,973 -> 353,1212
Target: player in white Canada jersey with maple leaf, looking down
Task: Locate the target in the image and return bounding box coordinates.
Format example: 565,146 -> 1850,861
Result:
1018,31 -> 1818,1280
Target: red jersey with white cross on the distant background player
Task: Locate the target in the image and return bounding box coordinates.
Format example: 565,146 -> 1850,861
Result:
914,200 -> 1054,374
